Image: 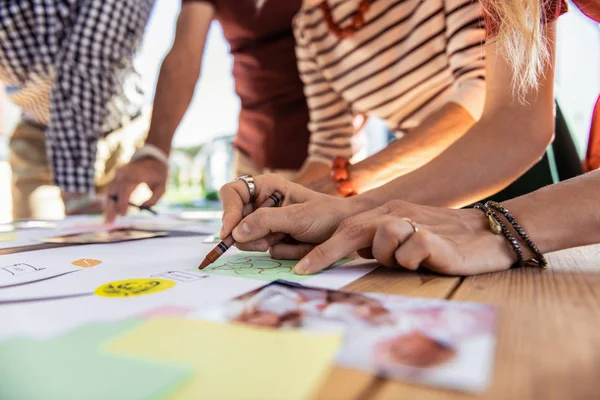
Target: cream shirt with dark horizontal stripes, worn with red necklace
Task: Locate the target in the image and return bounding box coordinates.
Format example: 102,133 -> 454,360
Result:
294,0 -> 485,162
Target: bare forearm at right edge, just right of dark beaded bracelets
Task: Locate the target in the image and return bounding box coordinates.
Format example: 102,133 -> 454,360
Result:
503,171 -> 600,253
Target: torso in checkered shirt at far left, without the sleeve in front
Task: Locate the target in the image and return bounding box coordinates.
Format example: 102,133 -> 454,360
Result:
0,0 -> 145,133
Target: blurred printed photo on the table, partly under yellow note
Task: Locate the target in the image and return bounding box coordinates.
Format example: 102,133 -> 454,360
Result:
200,283 -> 496,392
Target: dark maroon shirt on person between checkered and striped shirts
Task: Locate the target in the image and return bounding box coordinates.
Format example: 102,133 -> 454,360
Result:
182,0 -> 310,169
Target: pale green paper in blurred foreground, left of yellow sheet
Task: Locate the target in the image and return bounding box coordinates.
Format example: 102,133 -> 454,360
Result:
0,321 -> 192,400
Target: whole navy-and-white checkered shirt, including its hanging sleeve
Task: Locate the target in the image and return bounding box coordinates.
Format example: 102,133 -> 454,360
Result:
0,0 -> 154,193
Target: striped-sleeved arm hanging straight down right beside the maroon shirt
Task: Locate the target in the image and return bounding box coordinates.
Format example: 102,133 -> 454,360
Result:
294,21 -> 354,183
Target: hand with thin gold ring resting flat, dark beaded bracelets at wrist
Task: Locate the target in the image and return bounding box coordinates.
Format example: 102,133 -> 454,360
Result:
284,200 -> 516,275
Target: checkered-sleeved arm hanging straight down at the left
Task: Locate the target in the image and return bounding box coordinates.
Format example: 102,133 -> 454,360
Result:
46,0 -> 152,197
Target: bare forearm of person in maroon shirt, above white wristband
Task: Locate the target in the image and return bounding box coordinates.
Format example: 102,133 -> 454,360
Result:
146,49 -> 200,154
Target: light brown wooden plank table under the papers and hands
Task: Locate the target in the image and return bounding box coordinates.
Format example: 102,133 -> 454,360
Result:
0,245 -> 600,400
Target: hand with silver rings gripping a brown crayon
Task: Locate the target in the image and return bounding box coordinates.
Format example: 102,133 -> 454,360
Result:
221,175 -> 366,258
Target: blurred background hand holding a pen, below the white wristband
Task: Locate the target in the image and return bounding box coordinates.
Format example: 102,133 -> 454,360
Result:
104,158 -> 168,223
